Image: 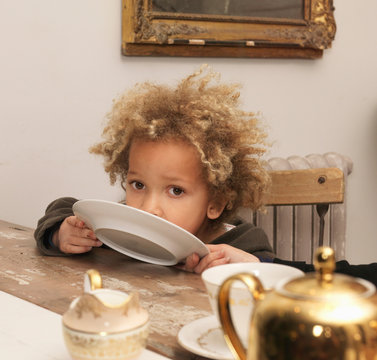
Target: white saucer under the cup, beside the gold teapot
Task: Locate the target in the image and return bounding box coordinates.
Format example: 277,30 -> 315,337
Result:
178,315 -> 234,360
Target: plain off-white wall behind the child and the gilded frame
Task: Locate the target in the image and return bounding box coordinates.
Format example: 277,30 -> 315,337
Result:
0,0 -> 377,263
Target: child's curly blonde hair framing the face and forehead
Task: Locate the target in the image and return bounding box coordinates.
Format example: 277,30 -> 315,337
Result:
90,67 -> 269,223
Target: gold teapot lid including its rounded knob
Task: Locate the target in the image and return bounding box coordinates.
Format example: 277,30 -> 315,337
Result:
276,247 -> 375,302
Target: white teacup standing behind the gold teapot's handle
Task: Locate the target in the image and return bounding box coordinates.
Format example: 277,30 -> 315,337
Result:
202,263 -> 304,347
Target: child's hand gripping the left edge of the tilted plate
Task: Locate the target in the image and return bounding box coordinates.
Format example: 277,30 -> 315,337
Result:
52,216 -> 102,254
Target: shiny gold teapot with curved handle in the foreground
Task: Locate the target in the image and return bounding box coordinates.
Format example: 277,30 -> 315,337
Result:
218,247 -> 377,360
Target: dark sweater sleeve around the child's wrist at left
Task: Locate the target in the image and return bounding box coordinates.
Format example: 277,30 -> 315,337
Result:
34,197 -> 77,256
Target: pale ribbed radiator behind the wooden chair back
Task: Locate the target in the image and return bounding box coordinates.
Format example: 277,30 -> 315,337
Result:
240,152 -> 353,263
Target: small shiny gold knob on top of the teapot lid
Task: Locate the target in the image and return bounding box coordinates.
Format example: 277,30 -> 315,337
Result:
314,246 -> 335,286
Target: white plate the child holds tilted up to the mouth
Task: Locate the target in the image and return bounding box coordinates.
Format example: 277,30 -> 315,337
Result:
72,199 -> 208,265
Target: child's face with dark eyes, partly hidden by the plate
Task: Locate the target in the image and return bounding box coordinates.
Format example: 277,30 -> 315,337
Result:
126,140 -> 222,238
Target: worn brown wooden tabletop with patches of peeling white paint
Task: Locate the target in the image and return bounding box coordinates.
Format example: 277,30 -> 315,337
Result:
0,221 -> 212,360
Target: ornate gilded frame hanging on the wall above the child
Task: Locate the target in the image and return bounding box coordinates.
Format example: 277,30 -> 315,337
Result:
122,0 -> 336,59
